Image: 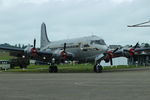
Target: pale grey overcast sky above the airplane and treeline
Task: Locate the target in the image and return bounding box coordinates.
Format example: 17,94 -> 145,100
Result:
0,0 -> 150,45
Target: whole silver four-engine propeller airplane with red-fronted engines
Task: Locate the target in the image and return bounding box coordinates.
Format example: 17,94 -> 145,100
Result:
0,23 -> 150,72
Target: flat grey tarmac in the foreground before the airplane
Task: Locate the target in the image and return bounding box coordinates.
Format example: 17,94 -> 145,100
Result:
0,70 -> 150,100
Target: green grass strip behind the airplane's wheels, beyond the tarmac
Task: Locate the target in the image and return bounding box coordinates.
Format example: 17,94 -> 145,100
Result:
0,64 -> 149,73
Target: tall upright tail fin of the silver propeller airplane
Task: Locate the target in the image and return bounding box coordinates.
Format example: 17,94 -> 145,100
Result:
41,23 -> 50,48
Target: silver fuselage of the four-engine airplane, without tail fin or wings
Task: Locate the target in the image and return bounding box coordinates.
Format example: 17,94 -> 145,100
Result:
41,35 -> 108,62
